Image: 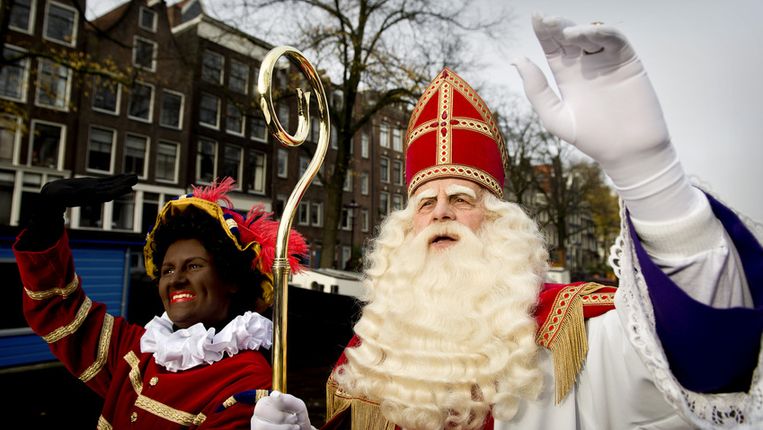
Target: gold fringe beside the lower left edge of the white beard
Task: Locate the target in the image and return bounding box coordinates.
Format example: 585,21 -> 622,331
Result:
326,377 -> 395,430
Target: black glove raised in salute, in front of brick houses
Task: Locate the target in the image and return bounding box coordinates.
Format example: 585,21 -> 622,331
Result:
16,173 -> 138,250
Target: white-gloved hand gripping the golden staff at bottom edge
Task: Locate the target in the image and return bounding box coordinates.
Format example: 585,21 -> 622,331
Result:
251,391 -> 315,430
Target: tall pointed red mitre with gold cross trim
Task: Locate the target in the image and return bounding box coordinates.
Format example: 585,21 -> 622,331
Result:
405,68 -> 508,198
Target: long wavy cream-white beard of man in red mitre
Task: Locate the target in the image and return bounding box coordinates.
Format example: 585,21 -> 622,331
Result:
334,203 -> 547,430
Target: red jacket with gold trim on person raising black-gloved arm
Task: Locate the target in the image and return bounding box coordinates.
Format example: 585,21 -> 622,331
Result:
14,233 -> 271,429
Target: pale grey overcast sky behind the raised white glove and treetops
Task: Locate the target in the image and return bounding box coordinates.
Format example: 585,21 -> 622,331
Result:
88,0 -> 763,222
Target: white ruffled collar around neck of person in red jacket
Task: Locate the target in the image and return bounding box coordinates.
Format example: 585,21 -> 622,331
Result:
140,311 -> 273,372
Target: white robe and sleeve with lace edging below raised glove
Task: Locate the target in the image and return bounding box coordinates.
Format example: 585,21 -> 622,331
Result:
494,193 -> 763,430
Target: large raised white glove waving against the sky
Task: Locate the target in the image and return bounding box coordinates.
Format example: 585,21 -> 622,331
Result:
514,15 -> 704,221
